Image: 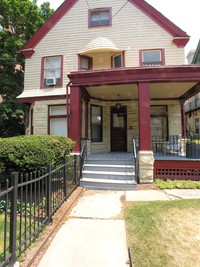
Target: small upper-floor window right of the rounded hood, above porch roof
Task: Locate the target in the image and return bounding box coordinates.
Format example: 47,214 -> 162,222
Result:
140,49 -> 165,66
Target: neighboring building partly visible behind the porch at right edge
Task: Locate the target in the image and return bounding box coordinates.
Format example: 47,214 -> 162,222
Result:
185,40 -> 200,137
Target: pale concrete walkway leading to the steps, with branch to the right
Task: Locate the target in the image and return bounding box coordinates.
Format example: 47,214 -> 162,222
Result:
38,190 -> 200,267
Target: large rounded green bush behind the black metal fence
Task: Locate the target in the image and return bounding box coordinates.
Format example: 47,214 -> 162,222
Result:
0,135 -> 74,179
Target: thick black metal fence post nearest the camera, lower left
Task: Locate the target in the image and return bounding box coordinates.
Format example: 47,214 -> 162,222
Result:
9,172 -> 19,266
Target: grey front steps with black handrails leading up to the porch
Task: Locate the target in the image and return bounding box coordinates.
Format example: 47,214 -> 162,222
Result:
80,153 -> 137,190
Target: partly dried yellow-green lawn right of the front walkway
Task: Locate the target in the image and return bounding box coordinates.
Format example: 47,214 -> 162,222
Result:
124,199 -> 200,267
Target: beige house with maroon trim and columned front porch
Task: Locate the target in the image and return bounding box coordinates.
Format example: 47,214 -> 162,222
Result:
19,0 -> 200,182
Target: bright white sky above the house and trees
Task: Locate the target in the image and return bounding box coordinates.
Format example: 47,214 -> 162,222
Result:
37,0 -> 200,54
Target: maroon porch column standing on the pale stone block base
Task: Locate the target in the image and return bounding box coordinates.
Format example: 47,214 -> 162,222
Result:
138,82 -> 152,151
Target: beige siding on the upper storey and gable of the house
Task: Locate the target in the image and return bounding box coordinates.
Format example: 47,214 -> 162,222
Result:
22,0 -> 184,97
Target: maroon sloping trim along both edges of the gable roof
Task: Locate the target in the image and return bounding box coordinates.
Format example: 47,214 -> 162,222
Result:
21,0 -> 190,58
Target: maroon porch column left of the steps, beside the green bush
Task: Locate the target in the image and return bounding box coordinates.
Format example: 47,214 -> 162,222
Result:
70,85 -> 81,153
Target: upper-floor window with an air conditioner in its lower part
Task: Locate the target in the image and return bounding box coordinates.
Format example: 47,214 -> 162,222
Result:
41,56 -> 63,87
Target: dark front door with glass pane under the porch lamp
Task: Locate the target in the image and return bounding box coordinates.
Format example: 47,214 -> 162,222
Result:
110,107 -> 127,151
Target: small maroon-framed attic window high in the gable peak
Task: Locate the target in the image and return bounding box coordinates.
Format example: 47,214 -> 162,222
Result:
88,8 -> 111,27
